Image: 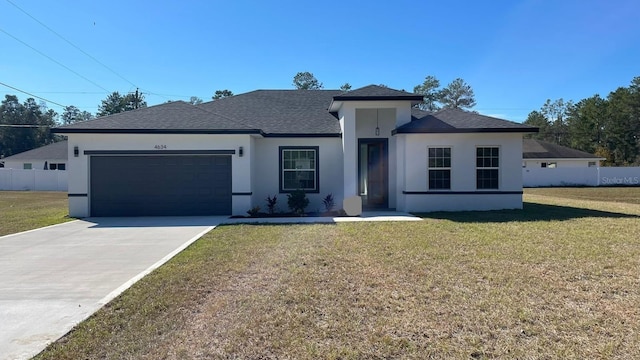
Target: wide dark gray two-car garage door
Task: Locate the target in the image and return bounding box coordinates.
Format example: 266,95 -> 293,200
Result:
90,155 -> 231,216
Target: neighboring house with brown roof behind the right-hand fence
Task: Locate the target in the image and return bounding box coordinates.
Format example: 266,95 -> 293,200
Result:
522,139 -> 605,168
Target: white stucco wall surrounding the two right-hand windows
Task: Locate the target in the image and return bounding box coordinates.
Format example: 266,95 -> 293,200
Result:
396,133 -> 522,211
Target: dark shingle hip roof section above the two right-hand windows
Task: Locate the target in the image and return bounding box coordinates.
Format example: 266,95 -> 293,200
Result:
394,108 -> 538,134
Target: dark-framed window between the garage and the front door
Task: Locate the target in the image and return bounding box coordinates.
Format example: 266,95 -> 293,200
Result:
280,146 -> 319,192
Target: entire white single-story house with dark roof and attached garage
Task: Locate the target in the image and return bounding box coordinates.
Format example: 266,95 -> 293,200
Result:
53,85 -> 537,217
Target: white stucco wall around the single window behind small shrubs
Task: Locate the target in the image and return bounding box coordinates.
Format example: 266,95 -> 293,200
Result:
252,137 -> 344,214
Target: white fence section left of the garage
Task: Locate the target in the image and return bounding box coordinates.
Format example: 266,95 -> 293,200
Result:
0,168 -> 68,191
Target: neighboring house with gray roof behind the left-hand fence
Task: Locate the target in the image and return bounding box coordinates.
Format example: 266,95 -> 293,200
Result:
2,141 -> 68,170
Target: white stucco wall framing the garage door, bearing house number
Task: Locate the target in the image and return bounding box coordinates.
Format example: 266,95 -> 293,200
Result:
67,134 -> 253,217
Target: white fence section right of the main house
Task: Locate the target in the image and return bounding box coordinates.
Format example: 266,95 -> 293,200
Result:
522,167 -> 640,187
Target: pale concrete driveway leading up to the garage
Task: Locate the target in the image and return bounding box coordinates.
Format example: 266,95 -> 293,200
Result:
0,217 -> 226,360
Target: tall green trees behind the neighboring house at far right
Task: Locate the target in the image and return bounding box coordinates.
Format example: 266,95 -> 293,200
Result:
524,77 -> 640,166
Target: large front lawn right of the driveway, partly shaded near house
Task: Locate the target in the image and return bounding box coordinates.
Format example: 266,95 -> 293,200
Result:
38,195 -> 640,359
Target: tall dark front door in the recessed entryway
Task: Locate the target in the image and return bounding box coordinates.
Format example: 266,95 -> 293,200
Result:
358,139 -> 389,208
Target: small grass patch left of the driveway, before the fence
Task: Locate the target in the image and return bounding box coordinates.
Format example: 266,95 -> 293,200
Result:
0,191 -> 73,236
